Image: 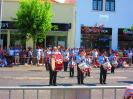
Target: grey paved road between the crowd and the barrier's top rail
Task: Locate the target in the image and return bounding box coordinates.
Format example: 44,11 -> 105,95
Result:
0,66 -> 133,86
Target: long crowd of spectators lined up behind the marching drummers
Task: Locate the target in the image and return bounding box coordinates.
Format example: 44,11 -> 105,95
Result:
0,45 -> 133,67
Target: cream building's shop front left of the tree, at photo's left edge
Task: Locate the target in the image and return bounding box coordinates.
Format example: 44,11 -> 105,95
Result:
0,21 -> 26,48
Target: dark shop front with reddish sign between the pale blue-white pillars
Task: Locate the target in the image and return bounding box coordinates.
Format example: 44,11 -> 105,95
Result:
81,26 -> 112,49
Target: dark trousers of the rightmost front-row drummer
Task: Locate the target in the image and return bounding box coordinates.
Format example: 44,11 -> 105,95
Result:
100,66 -> 107,84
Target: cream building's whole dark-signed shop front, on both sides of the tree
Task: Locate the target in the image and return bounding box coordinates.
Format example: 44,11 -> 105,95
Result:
0,21 -> 71,48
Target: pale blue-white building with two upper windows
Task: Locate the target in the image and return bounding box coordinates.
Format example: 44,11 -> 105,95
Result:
75,0 -> 133,49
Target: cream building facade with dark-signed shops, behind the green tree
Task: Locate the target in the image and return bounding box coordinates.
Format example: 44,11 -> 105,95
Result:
1,0 -> 76,48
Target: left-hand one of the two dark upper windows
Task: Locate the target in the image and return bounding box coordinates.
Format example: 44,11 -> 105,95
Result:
93,0 -> 103,11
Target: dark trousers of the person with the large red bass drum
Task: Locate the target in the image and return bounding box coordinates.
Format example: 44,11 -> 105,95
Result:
49,66 -> 57,85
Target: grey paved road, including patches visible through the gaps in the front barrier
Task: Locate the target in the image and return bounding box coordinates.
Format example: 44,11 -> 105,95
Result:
0,66 -> 133,99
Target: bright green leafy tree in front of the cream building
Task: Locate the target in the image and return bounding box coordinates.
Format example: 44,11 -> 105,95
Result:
15,0 -> 52,55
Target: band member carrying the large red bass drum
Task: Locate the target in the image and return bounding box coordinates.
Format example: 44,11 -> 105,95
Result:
49,47 -> 63,86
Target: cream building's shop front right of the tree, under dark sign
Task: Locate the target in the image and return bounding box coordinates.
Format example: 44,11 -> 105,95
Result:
45,23 -> 71,48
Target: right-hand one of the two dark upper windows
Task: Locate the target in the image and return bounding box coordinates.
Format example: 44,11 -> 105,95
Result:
105,0 -> 115,11
